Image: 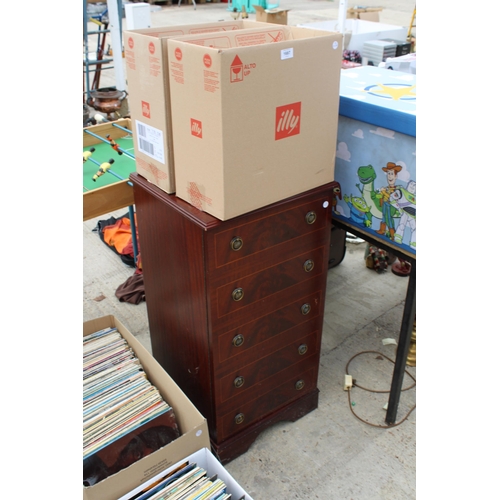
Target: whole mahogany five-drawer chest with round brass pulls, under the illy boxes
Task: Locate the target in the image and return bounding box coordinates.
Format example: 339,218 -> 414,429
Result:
130,173 -> 333,463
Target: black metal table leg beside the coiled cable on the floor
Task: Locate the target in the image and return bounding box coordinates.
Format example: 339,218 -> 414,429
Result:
385,260 -> 417,425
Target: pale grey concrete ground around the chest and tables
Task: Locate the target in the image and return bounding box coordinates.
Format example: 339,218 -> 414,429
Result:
83,0 -> 416,500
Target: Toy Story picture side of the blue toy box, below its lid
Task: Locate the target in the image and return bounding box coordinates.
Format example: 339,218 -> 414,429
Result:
332,116 -> 417,254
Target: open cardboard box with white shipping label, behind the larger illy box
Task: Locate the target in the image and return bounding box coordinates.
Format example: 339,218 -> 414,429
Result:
123,21 -> 274,194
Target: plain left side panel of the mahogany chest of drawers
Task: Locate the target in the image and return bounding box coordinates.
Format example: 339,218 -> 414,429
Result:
134,177 -> 213,422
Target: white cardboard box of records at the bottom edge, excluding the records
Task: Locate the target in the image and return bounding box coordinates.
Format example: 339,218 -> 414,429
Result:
118,448 -> 253,500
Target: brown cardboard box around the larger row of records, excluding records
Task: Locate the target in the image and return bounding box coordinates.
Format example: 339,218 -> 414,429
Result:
83,316 -> 210,500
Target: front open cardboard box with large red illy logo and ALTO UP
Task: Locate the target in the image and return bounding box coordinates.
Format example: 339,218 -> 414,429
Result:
168,24 -> 342,220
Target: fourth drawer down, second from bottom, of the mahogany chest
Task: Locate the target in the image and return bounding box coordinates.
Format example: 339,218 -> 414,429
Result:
215,331 -> 321,413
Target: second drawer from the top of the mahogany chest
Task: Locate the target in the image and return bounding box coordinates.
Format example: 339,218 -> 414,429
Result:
213,247 -> 325,319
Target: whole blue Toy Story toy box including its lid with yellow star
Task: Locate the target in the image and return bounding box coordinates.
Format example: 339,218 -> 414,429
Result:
332,66 -> 417,256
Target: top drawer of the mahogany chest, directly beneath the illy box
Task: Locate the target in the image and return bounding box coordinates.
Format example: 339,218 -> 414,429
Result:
211,197 -> 331,270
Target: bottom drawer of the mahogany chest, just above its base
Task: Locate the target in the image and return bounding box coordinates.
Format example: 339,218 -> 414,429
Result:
216,364 -> 318,440
